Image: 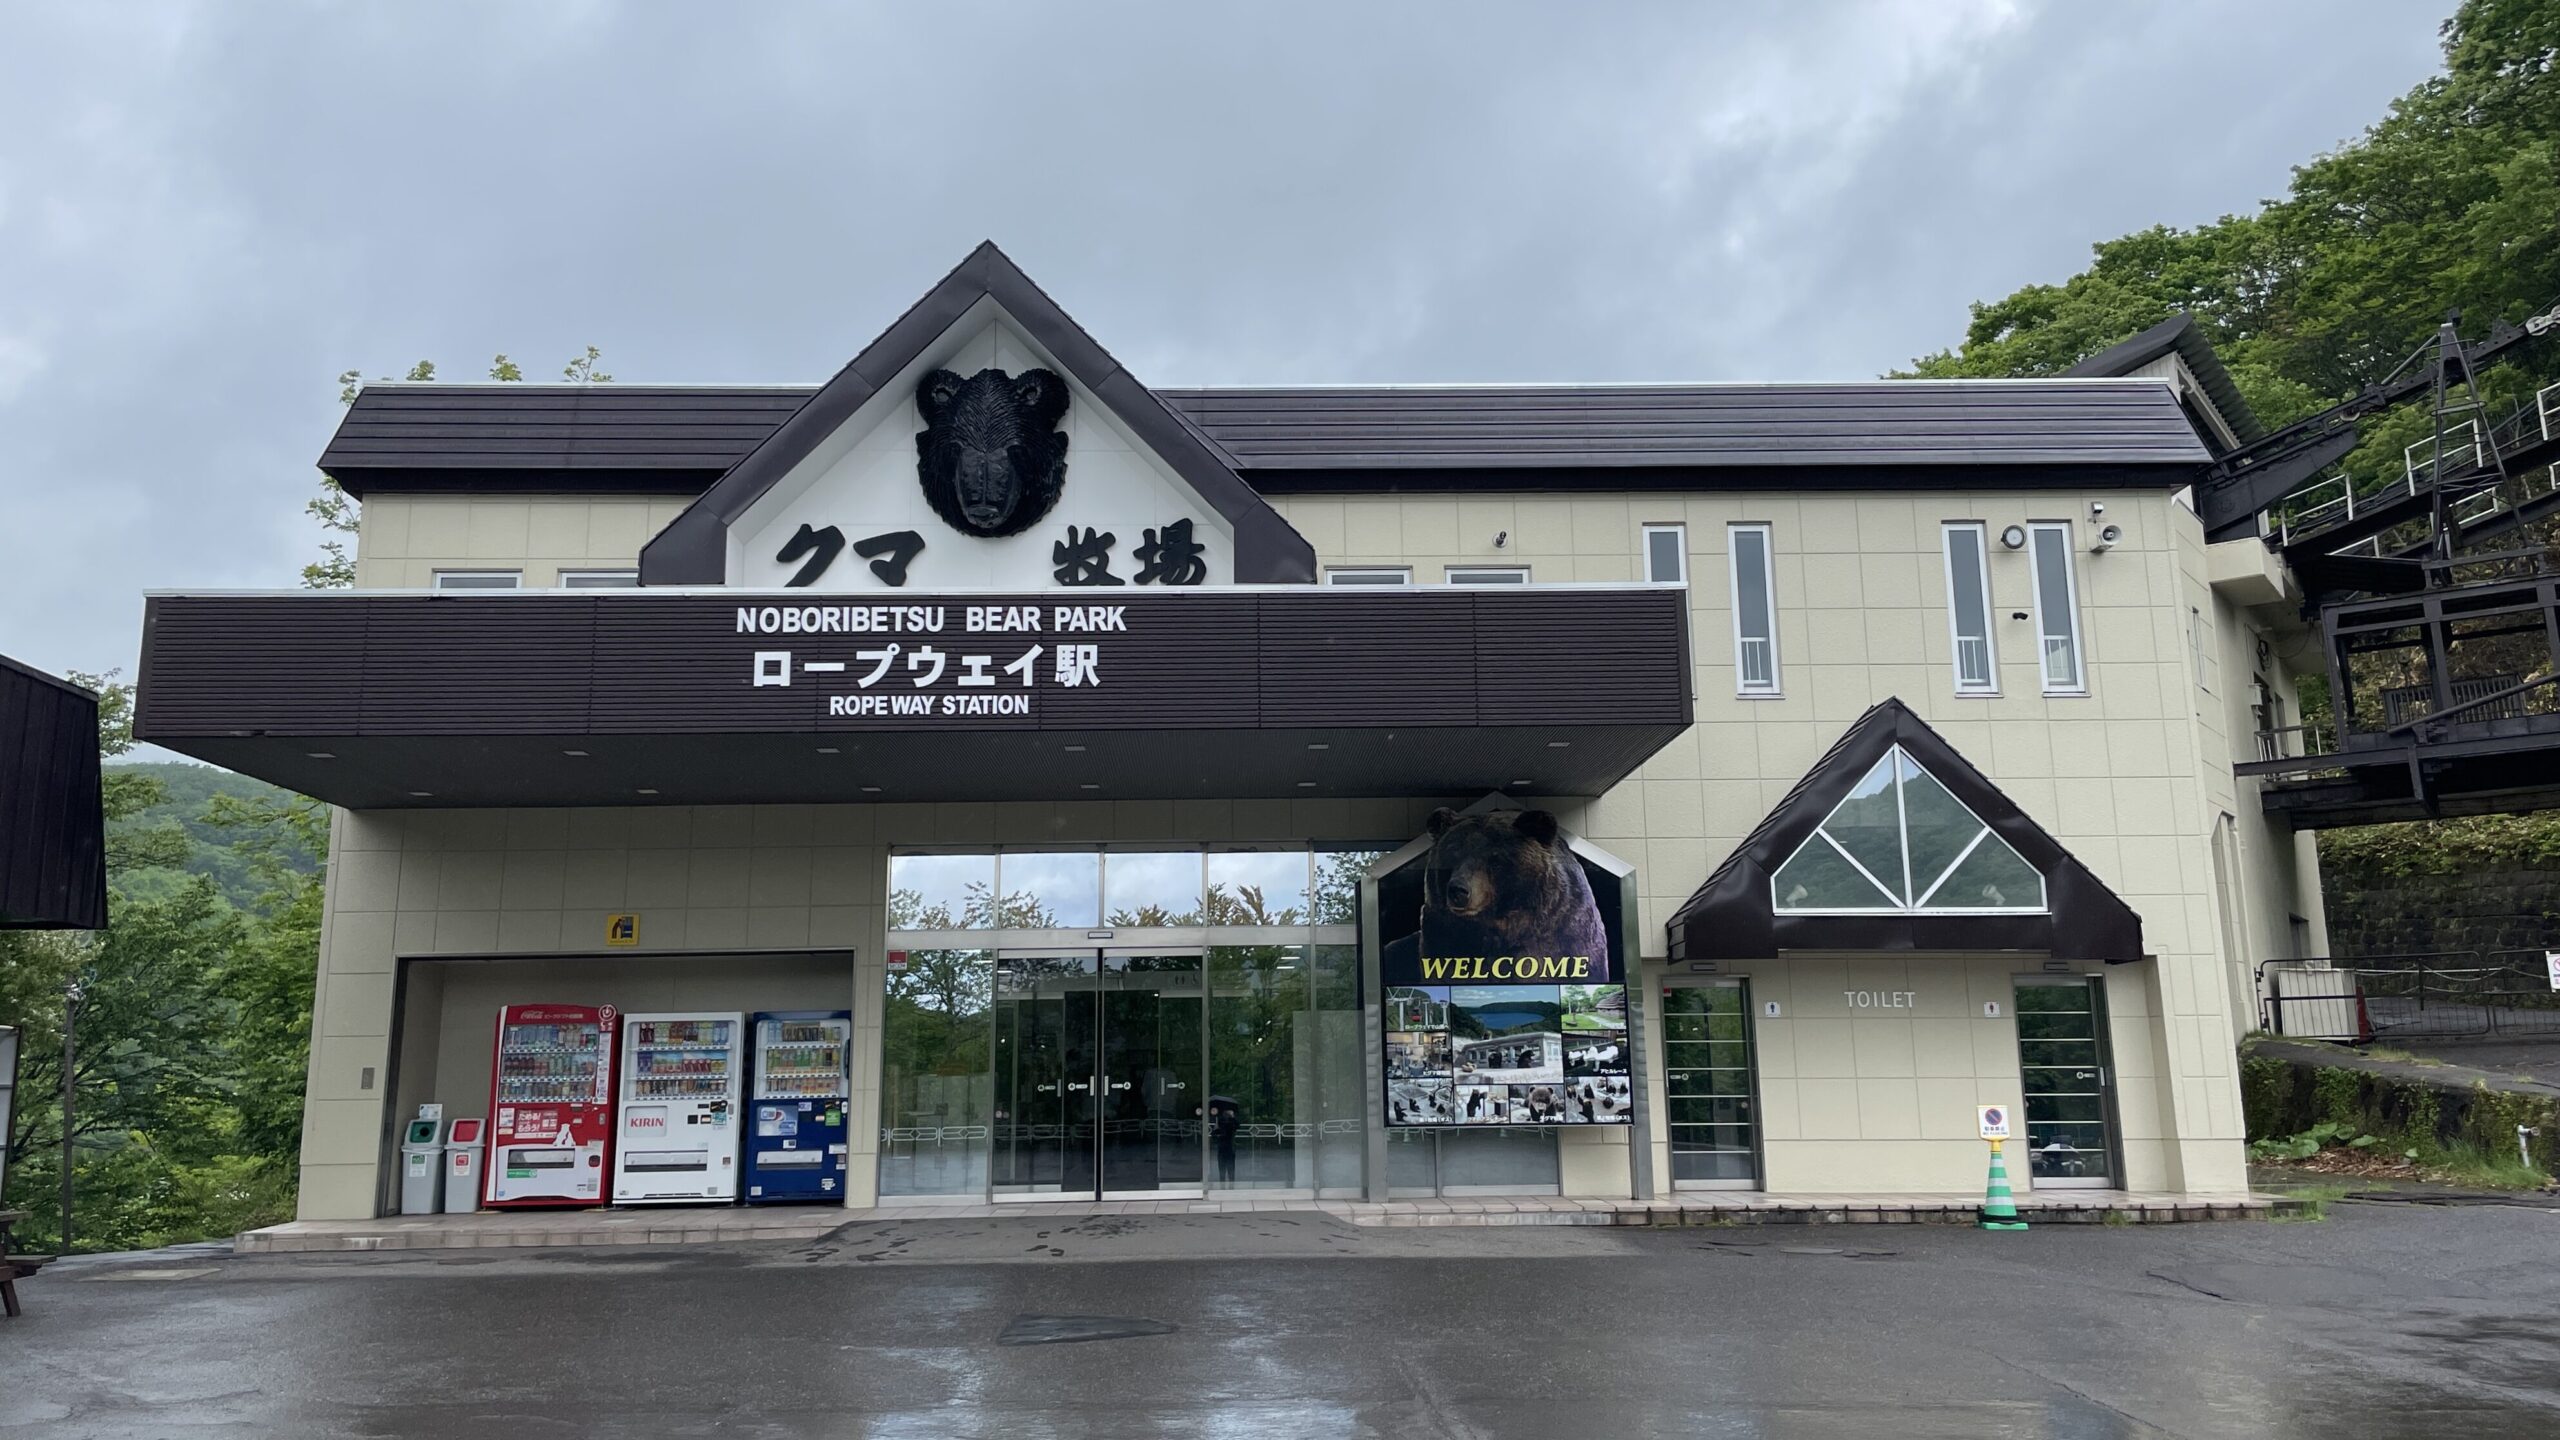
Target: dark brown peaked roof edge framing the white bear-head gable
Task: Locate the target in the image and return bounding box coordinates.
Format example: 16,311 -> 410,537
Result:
640,241 -> 1316,584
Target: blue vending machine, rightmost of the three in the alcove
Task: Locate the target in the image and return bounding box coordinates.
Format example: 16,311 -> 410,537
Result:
740,1010 -> 852,1204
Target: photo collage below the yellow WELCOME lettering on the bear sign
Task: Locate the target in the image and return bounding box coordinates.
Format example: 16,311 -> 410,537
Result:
1385,984 -> 1633,1127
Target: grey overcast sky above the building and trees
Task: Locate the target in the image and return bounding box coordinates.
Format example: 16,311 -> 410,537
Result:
0,0 -> 2440,671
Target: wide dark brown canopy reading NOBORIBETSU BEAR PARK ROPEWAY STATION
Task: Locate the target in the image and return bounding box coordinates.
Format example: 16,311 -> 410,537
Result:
136,587 -> 1690,807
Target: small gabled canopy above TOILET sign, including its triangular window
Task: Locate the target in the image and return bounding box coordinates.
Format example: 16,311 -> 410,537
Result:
1669,700 -> 2143,961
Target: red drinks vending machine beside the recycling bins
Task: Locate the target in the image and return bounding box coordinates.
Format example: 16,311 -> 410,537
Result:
481,1004 -> 614,1209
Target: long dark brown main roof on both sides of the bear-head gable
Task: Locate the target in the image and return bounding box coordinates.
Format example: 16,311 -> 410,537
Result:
320,379 -> 2209,497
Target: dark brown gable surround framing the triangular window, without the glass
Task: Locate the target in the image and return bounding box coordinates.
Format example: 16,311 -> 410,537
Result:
1667,700 -> 2143,961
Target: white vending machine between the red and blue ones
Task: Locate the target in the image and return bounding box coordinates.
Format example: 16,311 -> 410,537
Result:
614,1012 -> 748,1204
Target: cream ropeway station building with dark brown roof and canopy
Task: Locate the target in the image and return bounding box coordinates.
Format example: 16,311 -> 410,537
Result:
124,246 -> 2319,1204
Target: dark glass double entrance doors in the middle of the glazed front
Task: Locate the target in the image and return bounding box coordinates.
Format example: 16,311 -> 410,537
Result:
991,953 -> 1206,1199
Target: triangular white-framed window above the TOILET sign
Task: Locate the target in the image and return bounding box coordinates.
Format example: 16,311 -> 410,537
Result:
1769,746 -> 2045,915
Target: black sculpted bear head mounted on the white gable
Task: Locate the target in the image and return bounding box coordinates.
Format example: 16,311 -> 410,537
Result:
916,369 -> 1068,538
